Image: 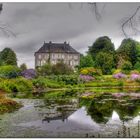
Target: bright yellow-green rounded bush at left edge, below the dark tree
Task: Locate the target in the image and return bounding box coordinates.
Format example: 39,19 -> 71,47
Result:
0,65 -> 20,78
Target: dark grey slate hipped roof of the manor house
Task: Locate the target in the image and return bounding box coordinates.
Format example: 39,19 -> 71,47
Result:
35,42 -> 79,54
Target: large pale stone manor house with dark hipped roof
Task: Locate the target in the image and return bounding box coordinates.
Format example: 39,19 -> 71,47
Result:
35,41 -> 80,69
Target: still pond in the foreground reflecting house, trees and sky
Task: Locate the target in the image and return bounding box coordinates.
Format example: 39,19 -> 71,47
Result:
0,93 -> 140,138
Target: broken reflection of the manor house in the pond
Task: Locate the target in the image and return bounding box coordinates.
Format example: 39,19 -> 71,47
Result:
36,101 -> 78,123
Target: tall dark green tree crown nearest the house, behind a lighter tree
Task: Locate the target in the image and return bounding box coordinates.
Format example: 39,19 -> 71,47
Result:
88,36 -> 115,60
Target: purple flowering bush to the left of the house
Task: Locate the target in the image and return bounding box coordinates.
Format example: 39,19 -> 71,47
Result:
21,69 -> 36,79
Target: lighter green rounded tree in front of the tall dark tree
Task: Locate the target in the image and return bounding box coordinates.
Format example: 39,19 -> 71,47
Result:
95,52 -> 114,74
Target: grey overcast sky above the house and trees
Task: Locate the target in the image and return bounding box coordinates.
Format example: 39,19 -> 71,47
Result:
0,3 -> 140,68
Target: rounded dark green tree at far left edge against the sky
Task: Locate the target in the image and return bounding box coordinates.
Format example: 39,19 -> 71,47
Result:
0,48 -> 17,66
